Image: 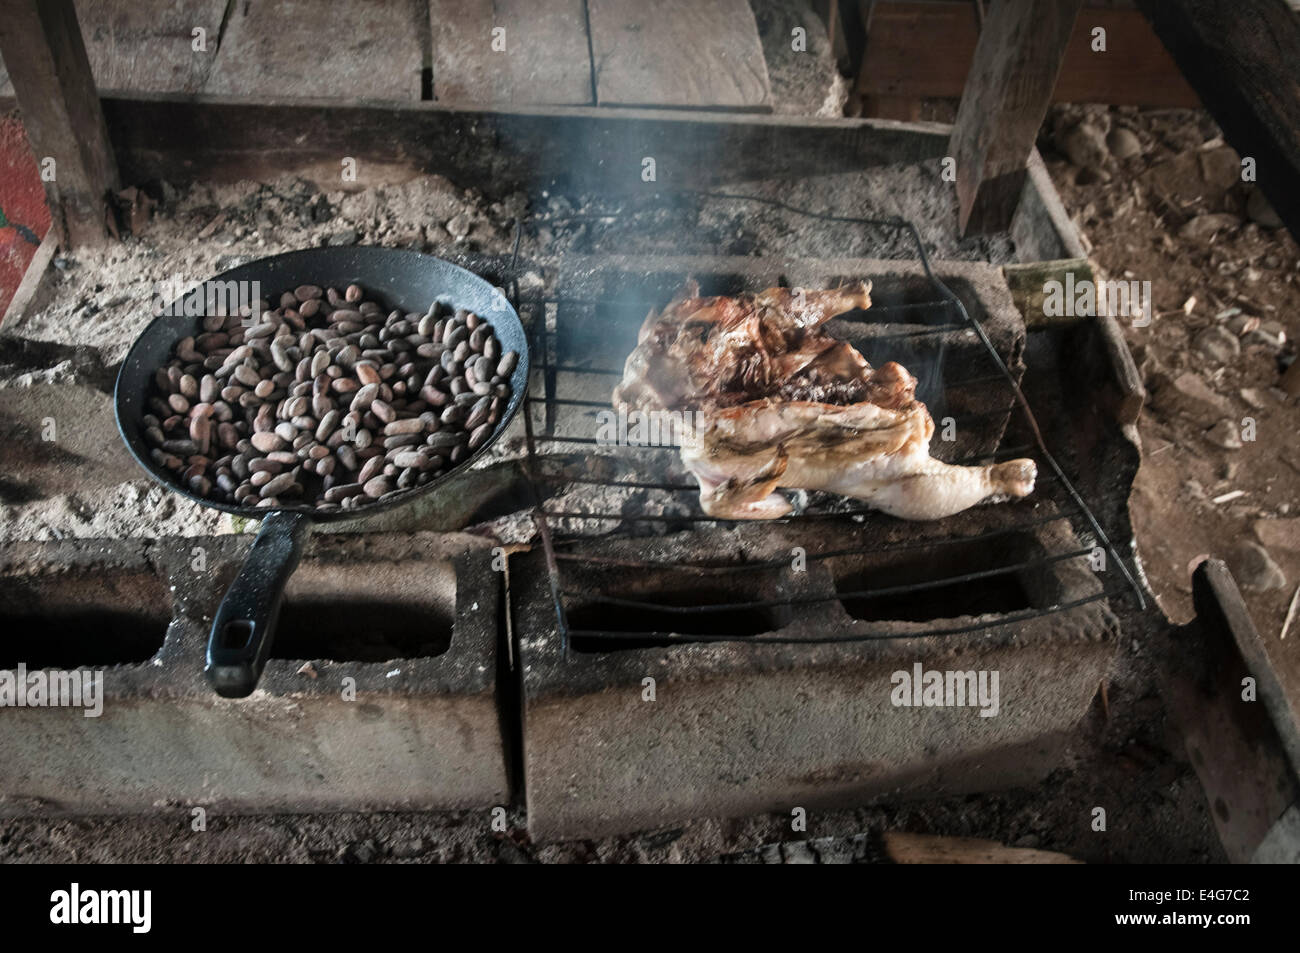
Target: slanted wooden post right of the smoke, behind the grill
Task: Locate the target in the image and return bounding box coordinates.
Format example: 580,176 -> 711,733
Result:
948,0 -> 1083,235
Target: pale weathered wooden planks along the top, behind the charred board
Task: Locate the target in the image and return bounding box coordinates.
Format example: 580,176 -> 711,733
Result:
0,0 -> 771,112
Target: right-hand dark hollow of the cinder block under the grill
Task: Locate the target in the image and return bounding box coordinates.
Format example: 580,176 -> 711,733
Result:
832,536 -> 1050,621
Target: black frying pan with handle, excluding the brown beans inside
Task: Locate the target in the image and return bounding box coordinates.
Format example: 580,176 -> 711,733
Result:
114,247 -> 528,698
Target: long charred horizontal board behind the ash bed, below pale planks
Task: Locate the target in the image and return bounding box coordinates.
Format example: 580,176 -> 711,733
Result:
104,95 -> 944,192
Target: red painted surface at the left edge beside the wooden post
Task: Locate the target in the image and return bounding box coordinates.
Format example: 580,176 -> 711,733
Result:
0,116 -> 49,315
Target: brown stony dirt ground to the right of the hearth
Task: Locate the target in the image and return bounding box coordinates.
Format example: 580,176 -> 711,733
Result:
1040,107 -> 1300,699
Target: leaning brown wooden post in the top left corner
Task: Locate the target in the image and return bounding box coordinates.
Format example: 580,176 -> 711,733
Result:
0,0 -> 117,247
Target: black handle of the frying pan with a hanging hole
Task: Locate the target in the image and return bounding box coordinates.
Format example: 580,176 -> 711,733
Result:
203,512 -> 308,698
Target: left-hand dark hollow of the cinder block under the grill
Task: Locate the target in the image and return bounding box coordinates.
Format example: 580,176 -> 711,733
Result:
568,572 -> 790,653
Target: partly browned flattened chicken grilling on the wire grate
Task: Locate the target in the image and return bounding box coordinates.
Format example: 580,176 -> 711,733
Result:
614,283 -> 1037,520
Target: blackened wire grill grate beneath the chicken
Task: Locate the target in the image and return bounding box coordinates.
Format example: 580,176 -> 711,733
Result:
508,190 -> 1147,655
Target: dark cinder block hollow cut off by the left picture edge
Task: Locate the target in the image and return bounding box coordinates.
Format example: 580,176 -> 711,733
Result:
0,569 -> 172,668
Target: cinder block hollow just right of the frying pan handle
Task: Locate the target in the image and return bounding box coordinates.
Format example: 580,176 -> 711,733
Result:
270,562 -> 456,662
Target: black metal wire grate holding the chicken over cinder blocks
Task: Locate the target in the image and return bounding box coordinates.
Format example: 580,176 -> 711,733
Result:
511,192 -> 1145,653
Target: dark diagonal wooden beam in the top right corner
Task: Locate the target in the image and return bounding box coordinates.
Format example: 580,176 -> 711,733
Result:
1138,0 -> 1300,238
